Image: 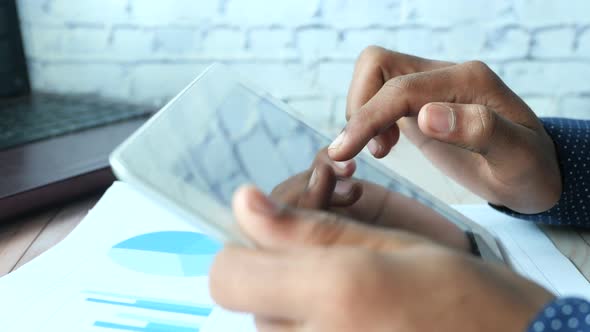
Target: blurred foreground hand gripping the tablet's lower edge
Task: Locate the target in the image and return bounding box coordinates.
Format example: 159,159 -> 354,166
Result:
210,188 -> 553,332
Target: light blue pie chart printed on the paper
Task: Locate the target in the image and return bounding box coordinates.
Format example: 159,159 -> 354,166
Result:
108,231 -> 221,277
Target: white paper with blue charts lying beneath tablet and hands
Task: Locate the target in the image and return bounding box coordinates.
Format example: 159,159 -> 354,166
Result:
0,182 -> 590,332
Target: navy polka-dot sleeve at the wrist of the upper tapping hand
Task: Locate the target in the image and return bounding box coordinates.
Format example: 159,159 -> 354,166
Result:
490,118 -> 590,227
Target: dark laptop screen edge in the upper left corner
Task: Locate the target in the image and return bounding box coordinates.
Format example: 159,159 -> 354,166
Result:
0,0 -> 29,97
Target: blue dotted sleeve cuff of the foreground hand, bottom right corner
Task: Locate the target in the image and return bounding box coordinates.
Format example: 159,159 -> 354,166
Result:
526,297 -> 590,332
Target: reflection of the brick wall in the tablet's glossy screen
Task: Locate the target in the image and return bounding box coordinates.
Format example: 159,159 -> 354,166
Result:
174,84 -> 407,205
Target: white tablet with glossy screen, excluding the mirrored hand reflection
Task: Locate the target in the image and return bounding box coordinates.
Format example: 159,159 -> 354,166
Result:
110,64 -> 502,260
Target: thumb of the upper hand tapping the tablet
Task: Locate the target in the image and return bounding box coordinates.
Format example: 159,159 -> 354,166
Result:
418,103 -> 530,162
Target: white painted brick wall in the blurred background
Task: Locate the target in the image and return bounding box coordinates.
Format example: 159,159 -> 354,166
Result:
19,0 -> 590,128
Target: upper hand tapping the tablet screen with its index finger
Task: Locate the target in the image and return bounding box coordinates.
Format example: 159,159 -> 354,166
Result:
329,47 -> 561,213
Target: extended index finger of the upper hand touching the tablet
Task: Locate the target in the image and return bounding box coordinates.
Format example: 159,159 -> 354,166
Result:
328,62 -> 495,161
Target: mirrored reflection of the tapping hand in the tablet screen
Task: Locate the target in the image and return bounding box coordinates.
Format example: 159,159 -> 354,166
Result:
270,149 -> 471,251
